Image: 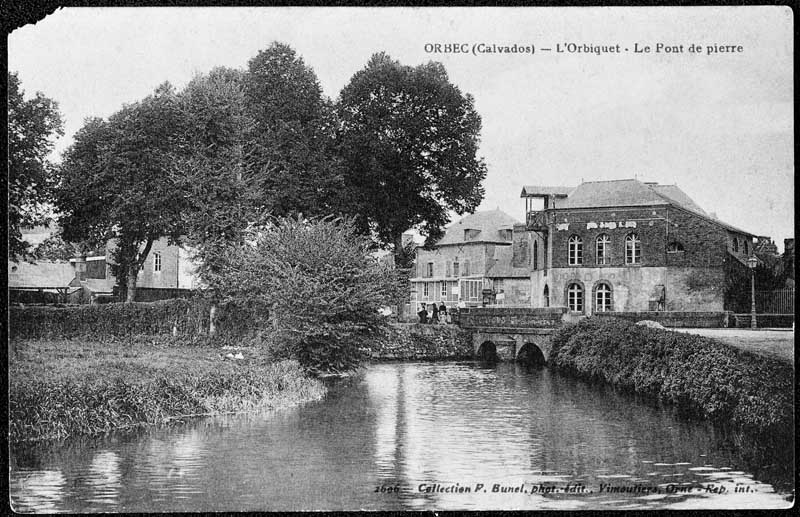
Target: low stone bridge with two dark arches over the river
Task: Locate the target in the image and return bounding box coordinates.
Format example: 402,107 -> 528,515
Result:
459,307 -> 566,364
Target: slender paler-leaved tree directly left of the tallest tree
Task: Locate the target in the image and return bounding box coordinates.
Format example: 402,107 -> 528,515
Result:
172,67 -> 263,334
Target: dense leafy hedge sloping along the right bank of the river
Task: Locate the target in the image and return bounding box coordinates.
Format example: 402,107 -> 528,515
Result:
550,318 -> 794,436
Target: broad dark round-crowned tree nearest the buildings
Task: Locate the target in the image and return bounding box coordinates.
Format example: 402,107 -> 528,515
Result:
338,53 -> 486,264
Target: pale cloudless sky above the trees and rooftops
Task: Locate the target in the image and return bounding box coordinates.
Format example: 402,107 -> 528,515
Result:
8,6 -> 794,250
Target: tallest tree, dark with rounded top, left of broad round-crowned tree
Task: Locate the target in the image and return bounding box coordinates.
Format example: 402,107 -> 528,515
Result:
244,42 -> 344,216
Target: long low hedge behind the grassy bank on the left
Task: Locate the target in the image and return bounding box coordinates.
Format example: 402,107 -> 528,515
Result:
9,298 -> 267,341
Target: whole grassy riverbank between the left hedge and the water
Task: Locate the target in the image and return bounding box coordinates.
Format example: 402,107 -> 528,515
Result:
8,340 -> 325,441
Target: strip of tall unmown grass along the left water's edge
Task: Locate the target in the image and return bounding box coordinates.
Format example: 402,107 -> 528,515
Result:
8,361 -> 325,441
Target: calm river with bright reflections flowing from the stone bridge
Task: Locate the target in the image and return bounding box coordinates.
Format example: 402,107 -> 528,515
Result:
10,362 -> 791,512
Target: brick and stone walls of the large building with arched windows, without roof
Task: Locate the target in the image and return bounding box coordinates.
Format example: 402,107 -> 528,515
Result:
531,207 -> 752,314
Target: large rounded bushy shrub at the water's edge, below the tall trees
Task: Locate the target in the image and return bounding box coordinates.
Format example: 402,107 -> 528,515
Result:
214,217 -> 396,373
